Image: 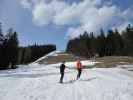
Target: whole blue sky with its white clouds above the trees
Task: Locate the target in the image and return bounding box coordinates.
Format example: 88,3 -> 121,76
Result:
0,0 -> 133,50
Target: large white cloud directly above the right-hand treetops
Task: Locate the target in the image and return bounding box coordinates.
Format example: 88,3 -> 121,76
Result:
67,6 -> 122,38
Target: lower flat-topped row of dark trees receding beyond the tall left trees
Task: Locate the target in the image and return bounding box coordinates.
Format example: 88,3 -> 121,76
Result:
18,44 -> 56,64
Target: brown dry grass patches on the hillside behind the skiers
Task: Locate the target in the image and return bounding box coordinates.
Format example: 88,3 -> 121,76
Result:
39,53 -> 133,68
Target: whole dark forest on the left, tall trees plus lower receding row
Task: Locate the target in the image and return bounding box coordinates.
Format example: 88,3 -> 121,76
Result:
0,23 -> 56,70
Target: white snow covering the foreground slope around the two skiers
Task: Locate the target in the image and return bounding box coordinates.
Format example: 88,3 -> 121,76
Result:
0,61 -> 133,100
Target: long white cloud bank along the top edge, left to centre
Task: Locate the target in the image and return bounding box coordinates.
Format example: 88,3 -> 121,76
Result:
21,0 -> 101,26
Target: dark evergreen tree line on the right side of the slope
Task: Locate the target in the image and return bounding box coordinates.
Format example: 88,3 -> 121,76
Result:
66,24 -> 133,58
